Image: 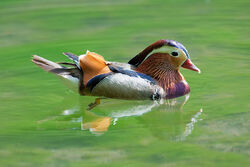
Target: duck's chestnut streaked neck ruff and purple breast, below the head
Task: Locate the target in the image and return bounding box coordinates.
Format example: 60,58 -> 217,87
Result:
136,56 -> 190,98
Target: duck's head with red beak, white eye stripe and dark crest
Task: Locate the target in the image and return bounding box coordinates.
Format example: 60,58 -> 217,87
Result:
128,40 -> 200,73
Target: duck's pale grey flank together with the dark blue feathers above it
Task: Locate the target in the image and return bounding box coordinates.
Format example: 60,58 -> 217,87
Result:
87,66 -> 165,99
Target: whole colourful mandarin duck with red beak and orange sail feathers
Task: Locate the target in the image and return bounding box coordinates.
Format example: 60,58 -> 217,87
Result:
32,40 -> 200,100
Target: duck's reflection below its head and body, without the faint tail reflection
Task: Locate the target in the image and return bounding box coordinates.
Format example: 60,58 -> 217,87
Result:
59,95 -> 202,141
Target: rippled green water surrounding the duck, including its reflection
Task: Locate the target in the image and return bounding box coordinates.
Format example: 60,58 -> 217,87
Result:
0,0 -> 250,167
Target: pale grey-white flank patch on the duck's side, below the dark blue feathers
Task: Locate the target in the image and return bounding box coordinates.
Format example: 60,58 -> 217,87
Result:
91,73 -> 165,99
